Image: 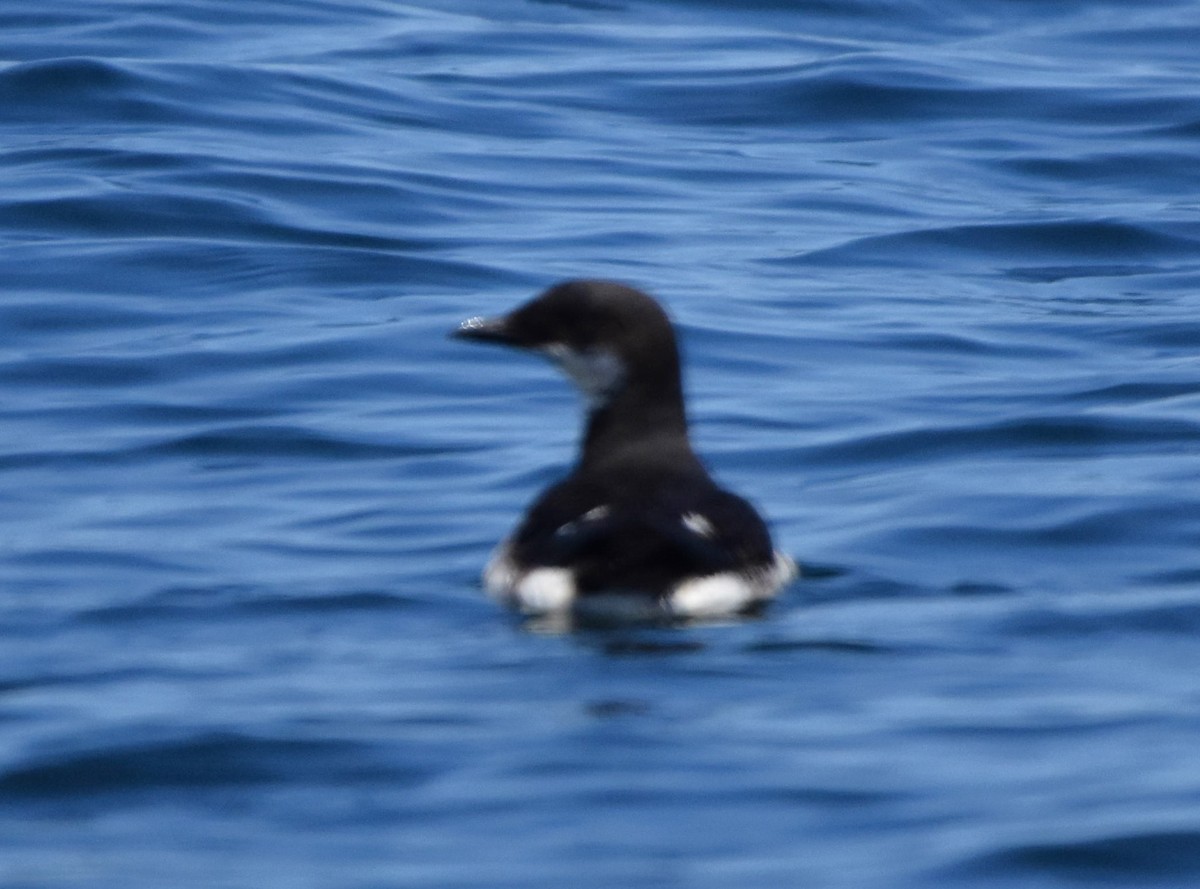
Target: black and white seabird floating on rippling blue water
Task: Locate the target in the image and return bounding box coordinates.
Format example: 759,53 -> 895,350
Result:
454,281 -> 797,618
